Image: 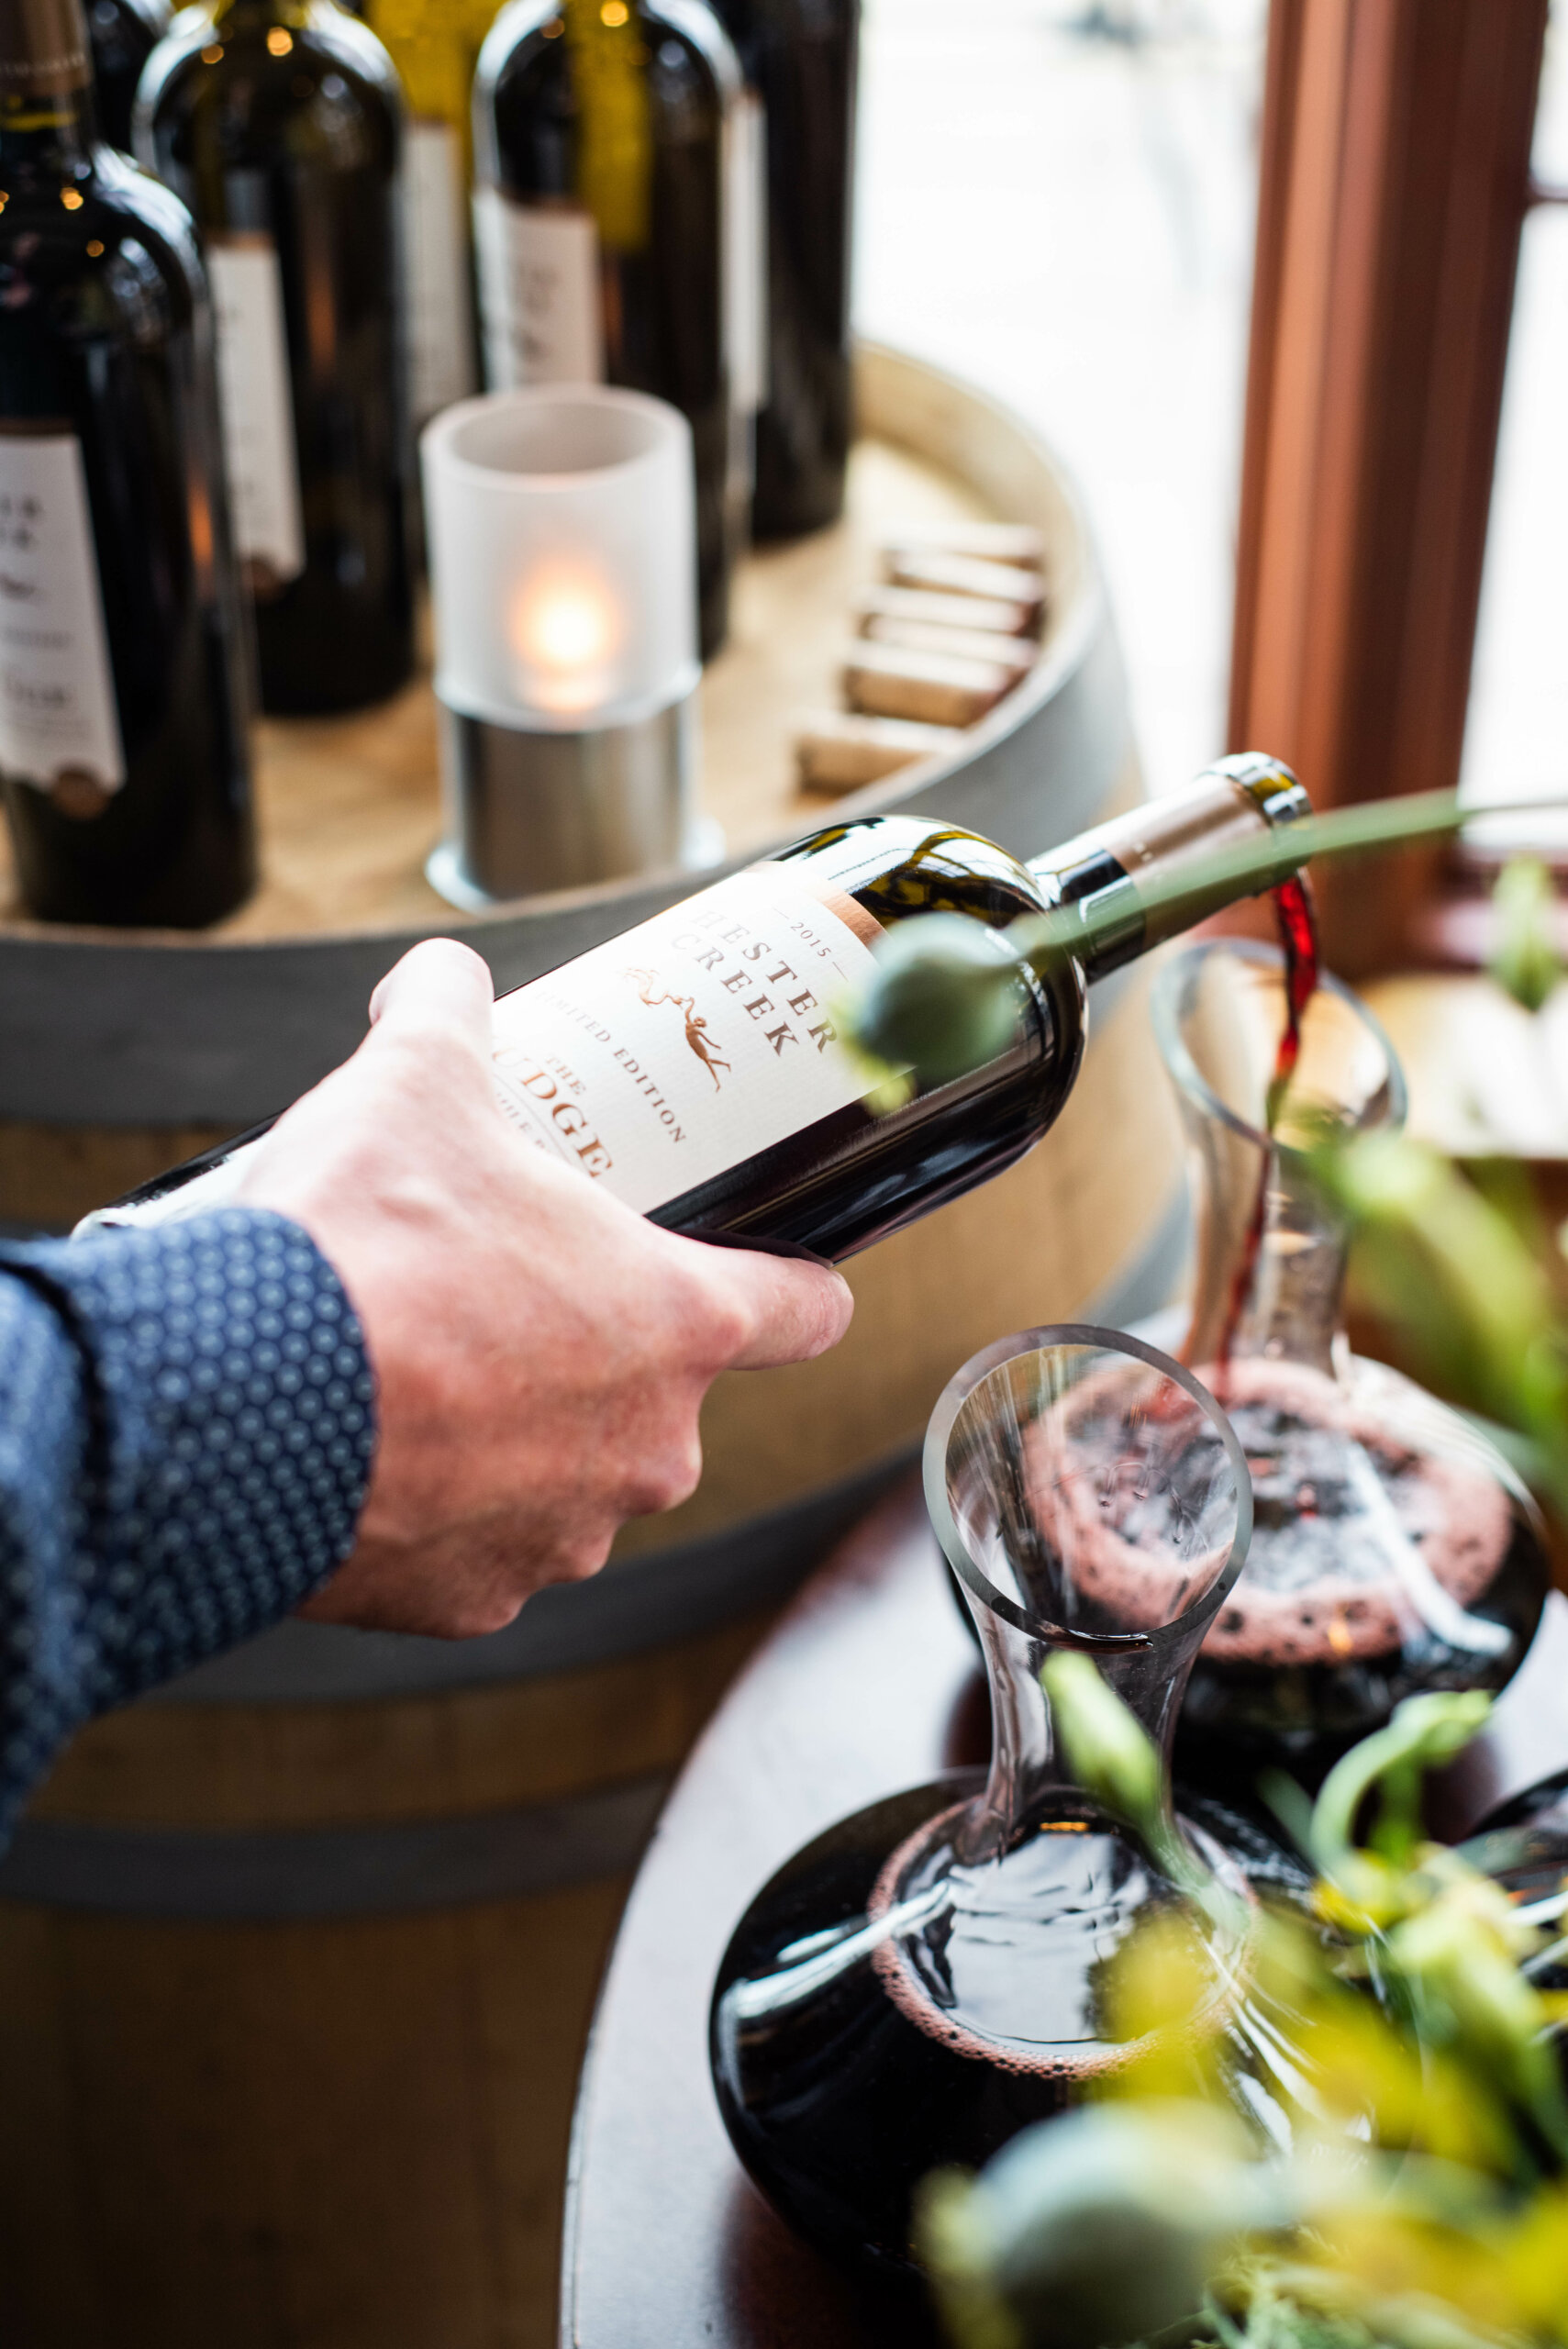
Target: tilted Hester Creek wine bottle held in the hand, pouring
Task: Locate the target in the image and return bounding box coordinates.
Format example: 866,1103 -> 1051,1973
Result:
72,759 -> 1307,1259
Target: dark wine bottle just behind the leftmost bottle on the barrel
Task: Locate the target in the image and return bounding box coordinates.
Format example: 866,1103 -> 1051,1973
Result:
136,0 -> 413,714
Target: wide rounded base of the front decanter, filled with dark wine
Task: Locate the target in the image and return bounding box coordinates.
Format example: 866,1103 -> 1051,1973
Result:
711,1774 -> 1258,2290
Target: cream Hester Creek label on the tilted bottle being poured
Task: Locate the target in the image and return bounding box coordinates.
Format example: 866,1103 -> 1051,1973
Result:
495,864 -> 878,1215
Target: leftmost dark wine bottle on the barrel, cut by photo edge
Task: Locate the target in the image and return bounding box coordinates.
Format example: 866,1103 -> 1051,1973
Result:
0,0 -> 256,928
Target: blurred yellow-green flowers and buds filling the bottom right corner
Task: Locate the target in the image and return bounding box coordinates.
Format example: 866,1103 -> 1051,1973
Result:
920,1675 -> 1568,2349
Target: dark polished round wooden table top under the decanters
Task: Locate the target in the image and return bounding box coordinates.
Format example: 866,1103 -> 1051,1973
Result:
561,1475 -> 1568,2349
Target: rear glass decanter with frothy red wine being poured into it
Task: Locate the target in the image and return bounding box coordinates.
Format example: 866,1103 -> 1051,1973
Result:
1152,940 -> 1550,1802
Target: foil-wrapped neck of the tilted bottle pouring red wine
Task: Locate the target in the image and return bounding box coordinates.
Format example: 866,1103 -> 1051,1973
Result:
1029,751 -> 1312,980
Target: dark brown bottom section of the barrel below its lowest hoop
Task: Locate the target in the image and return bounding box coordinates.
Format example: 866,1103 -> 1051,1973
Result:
0,1875 -> 629,2349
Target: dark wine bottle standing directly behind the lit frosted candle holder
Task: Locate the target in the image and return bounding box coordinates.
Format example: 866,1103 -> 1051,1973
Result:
474,0 -> 749,660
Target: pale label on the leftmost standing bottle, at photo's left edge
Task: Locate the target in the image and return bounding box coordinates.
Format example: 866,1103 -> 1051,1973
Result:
0,420 -> 125,818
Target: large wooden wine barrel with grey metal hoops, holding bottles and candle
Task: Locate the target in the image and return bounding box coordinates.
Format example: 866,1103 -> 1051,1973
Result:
0,348 -> 1181,2349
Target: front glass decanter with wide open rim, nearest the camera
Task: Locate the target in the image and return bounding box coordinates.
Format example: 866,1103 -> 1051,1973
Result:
711,1327 -> 1268,2281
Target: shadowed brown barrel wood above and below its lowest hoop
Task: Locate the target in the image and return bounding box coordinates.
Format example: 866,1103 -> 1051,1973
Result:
0,1619 -> 762,2349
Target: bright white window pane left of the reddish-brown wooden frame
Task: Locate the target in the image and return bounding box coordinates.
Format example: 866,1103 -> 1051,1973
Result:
854,0 -> 1268,789
